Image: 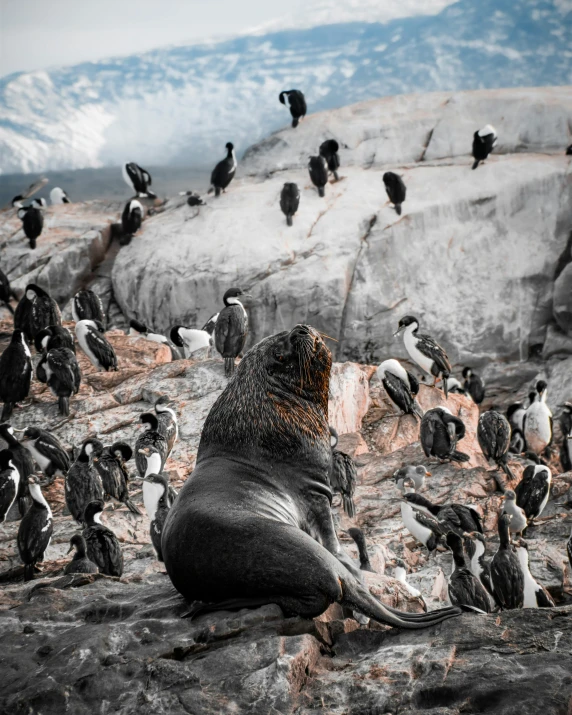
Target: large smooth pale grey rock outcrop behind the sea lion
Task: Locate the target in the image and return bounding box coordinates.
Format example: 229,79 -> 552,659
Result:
113,87 -> 572,364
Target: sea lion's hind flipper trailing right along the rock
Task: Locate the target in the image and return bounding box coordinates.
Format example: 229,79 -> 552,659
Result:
340,577 -> 461,629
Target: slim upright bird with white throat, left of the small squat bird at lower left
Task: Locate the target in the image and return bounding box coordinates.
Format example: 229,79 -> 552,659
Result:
16,476 -> 54,581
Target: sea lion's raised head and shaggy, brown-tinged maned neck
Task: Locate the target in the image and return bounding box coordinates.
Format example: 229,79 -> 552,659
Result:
199,325 -> 332,460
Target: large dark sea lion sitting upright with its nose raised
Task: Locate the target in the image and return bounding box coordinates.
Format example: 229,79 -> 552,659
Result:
162,325 -> 460,628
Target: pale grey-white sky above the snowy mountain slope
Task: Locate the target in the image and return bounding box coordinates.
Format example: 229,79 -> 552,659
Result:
0,0 -> 454,77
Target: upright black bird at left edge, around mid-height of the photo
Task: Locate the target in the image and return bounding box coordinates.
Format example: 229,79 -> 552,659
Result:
0,330 -> 32,422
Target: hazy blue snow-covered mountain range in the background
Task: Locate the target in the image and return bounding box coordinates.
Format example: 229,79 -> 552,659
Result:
0,0 -> 572,173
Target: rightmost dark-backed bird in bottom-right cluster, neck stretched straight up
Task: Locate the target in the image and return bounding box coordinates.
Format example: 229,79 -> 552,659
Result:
490,514 -> 524,611
